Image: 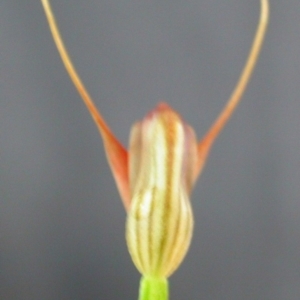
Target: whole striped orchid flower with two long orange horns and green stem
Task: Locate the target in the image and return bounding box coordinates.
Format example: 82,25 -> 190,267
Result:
41,0 -> 269,300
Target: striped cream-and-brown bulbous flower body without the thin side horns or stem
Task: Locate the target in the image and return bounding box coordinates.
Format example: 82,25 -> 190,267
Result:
126,103 -> 197,277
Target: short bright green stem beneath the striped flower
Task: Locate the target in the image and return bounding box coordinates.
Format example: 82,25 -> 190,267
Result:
139,276 -> 169,300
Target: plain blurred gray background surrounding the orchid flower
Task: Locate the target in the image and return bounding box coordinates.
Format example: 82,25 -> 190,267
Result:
0,0 -> 300,300
